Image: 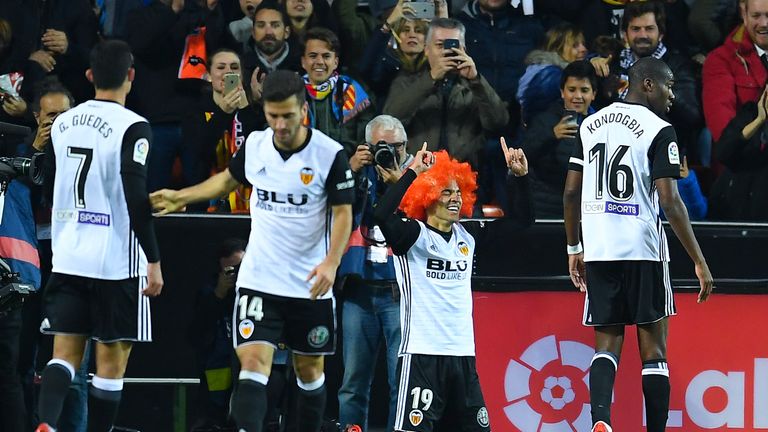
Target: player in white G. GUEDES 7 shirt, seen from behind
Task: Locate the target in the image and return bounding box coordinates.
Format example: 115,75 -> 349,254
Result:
37,40 -> 163,432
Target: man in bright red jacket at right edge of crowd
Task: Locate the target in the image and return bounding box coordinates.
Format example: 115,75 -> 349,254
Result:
702,0 -> 768,147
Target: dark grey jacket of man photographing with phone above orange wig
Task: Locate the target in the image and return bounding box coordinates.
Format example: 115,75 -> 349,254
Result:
383,66 -> 509,168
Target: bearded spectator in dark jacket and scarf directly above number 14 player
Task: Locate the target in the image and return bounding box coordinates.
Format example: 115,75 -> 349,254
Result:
243,0 -> 301,103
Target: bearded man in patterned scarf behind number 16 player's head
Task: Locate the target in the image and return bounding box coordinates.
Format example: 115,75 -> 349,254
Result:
598,1 -> 702,153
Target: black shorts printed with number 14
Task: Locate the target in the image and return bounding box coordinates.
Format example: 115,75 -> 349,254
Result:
232,288 -> 336,355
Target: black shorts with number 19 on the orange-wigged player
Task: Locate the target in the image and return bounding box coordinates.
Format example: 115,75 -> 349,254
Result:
395,354 -> 491,432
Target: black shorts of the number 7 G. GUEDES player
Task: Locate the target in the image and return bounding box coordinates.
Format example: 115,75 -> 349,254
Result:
40,273 -> 152,343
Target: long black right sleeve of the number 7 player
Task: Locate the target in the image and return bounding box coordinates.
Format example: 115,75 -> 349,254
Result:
120,122 -> 160,263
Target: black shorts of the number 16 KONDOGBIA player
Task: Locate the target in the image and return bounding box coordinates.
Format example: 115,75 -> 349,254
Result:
584,261 -> 677,326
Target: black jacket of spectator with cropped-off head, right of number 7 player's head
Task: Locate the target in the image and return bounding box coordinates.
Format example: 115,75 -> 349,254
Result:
126,1 -> 231,123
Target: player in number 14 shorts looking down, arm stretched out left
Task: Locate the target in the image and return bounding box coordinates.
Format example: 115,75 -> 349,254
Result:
150,71 -> 354,432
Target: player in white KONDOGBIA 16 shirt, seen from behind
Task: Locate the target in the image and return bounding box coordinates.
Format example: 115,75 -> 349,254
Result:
563,57 -> 713,432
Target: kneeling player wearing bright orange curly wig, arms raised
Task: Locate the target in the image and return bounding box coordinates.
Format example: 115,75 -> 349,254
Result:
375,138 -> 533,432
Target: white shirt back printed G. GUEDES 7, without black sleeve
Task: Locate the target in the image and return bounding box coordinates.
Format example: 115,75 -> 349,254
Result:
51,100 -> 149,280
